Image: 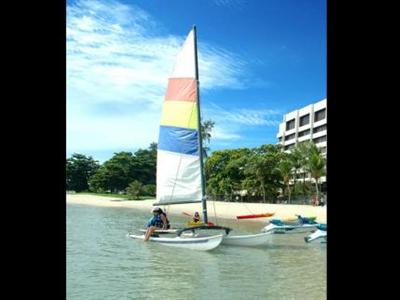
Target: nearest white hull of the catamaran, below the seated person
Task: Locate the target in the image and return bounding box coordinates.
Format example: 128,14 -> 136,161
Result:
128,234 -> 223,251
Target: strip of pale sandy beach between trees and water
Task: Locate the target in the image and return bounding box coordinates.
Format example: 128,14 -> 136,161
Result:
66,194 -> 327,223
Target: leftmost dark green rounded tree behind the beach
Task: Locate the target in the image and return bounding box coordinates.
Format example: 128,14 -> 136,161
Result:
66,153 -> 100,192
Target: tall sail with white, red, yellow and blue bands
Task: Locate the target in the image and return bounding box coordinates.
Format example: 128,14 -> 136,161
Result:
157,30 -> 202,204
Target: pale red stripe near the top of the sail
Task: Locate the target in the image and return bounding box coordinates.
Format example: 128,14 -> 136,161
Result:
165,78 -> 197,102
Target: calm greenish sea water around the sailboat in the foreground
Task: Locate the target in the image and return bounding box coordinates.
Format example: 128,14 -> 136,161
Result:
67,204 -> 326,300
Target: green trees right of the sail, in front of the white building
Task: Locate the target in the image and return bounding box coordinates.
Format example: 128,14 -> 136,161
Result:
205,142 -> 326,203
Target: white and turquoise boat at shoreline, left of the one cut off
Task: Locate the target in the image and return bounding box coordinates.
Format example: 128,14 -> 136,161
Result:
261,216 -> 319,233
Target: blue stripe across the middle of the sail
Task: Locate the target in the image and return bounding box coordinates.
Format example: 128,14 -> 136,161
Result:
158,126 -> 199,155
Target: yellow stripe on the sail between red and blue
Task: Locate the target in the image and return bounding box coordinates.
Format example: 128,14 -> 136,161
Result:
160,100 -> 198,129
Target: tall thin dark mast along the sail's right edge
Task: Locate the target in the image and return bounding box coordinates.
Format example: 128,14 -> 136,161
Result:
193,25 -> 208,224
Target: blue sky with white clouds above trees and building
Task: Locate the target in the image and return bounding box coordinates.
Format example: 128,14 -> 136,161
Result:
67,0 -> 326,162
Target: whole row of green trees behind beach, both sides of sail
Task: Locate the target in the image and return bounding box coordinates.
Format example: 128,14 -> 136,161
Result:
66,139 -> 326,203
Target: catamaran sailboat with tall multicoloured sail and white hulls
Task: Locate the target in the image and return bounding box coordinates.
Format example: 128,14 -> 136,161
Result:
130,26 -> 270,250
